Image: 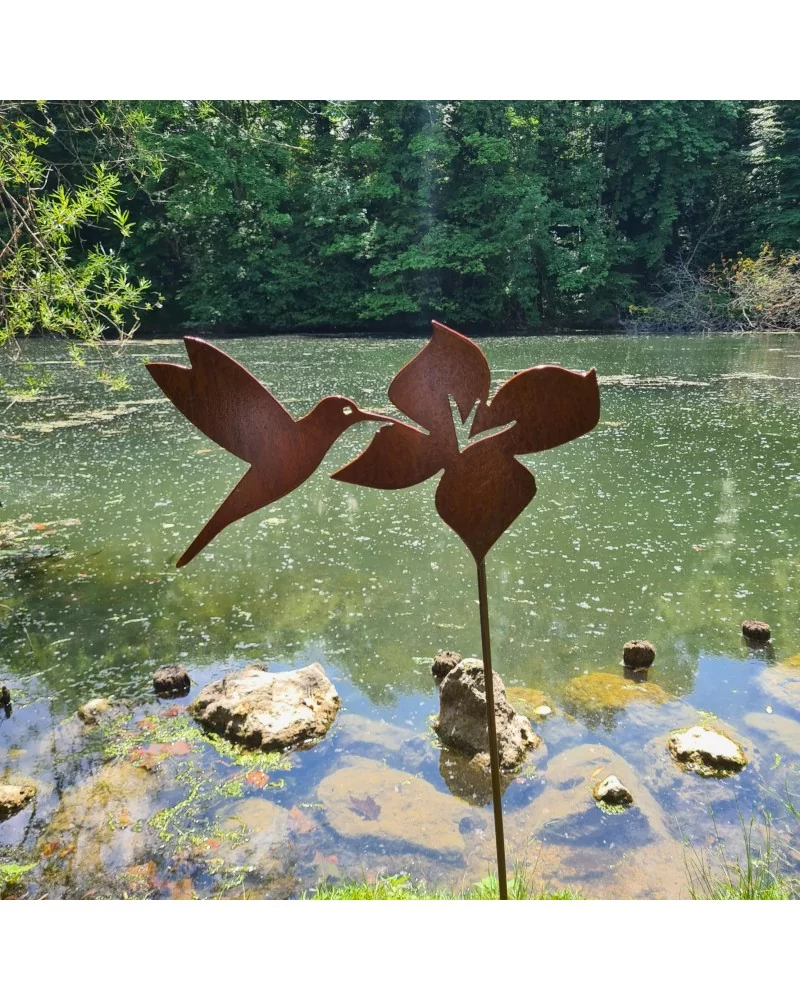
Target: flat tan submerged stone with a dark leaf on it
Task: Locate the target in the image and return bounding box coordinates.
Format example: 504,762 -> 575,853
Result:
317,757 -> 472,854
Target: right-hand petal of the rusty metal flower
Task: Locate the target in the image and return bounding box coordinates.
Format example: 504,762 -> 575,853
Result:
470,365 -> 600,455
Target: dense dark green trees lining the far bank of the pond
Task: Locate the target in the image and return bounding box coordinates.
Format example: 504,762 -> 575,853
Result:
0,101 -> 800,332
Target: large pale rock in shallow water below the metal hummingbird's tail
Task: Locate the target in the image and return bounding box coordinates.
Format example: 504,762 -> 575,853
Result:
189,663 -> 341,750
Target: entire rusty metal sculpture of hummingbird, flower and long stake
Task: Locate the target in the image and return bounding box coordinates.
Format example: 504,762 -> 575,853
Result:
147,322 -> 600,899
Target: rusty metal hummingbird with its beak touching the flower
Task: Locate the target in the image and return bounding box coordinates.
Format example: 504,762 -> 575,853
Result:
147,337 -> 390,567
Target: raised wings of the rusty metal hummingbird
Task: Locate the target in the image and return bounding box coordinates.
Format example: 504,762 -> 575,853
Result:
147,337 -> 294,464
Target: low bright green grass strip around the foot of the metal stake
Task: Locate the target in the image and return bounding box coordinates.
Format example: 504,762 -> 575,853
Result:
303,865 -> 581,900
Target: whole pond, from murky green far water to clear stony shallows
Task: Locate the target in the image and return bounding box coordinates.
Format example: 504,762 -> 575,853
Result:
0,335 -> 800,897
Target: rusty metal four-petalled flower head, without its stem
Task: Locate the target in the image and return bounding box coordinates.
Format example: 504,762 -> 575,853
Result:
333,322 -> 600,564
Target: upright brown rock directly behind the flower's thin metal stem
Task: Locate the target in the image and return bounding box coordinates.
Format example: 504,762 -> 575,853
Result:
433,660 -> 542,769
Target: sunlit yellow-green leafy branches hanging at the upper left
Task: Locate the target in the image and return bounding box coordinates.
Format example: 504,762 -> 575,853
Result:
0,102 -> 159,346
